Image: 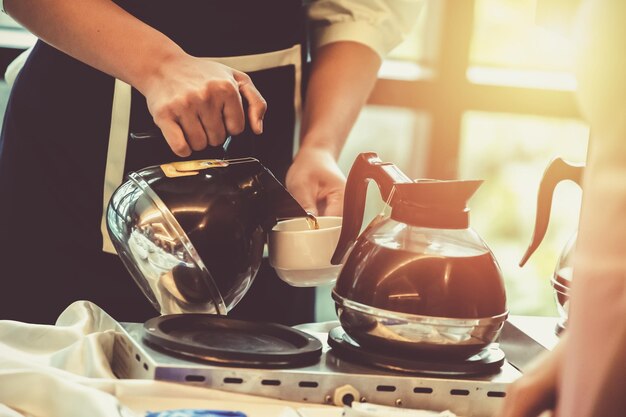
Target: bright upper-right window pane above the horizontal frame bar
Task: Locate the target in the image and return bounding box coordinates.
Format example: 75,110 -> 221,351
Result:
467,0 -> 576,91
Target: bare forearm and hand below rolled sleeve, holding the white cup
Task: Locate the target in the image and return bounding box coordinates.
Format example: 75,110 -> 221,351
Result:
286,42 -> 381,216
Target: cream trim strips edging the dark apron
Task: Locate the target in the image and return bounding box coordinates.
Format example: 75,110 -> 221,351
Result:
100,44 -> 302,254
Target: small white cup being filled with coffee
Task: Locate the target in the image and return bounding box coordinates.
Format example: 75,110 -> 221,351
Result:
268,216 -> 341,287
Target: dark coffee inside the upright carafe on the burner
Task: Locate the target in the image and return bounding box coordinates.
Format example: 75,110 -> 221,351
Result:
336,239 -> 506,318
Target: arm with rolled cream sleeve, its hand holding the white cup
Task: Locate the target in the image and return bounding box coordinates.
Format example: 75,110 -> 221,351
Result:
287,0 -> 423,215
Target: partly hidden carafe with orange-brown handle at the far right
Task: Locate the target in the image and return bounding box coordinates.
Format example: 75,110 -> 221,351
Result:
520,158 -> 584,331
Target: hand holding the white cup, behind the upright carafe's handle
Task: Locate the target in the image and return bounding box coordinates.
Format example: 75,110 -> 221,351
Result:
286,147 -> 346,216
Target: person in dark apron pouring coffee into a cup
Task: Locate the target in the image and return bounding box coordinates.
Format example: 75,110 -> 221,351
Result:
0,0 -> 419,323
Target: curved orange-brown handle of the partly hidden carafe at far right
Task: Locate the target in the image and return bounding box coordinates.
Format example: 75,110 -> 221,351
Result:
519,158 -> 585,266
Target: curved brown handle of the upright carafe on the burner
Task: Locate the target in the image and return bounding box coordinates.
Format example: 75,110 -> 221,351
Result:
331,152 -> 413,265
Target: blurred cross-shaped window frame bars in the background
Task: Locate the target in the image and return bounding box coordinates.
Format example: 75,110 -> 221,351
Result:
368,0 -> 581,179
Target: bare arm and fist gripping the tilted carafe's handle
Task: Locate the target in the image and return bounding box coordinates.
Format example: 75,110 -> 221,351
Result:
4,0 -> 266,156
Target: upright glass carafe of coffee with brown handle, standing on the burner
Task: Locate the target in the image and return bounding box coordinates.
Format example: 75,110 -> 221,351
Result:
333,153 -> 507,357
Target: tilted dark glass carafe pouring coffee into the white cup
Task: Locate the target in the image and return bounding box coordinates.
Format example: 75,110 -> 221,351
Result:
107,158 -> 308,314
